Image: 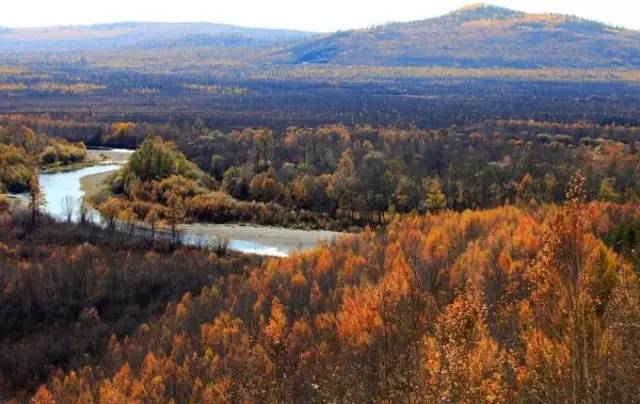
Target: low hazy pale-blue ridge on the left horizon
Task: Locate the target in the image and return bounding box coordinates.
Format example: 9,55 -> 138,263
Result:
0,22 -> 313,52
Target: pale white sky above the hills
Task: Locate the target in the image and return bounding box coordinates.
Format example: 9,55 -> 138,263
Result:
0,0 -> 640,32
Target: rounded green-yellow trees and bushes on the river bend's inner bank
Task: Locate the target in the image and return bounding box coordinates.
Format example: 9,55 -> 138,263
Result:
88,137 -> 362,231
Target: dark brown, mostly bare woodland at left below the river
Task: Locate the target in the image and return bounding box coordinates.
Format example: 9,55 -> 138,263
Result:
0,204 -> 252,402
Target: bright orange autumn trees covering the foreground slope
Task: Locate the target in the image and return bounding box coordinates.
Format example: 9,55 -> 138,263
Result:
3,175 -> 640,403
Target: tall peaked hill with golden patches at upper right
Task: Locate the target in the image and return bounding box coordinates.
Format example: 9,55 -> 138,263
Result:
280,4 -> 640,68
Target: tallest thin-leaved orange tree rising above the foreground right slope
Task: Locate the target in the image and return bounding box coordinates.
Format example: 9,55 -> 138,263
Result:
520,173 -> 626,403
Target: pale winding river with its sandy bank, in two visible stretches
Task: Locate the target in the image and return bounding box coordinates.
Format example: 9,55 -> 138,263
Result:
32,149 -> 342,257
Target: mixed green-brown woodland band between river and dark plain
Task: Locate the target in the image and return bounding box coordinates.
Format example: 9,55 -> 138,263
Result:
94,121 -> 640,229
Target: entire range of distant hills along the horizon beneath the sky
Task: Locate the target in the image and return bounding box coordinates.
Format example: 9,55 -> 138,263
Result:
0,4 -> 640,69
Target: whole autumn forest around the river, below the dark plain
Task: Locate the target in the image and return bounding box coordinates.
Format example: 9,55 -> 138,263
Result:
0,108 -> 640,403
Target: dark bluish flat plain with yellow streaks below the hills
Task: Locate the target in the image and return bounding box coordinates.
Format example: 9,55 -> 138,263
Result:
0,58 -> 640,129
